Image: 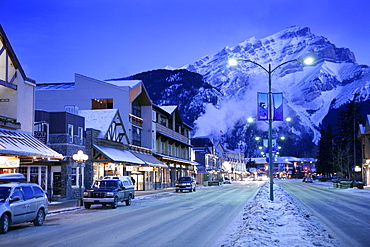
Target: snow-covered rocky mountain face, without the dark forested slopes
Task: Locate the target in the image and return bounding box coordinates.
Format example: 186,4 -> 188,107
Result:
183,27 -> 370,154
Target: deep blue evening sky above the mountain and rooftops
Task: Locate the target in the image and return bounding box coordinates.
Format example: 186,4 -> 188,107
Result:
0,0 -> 370,82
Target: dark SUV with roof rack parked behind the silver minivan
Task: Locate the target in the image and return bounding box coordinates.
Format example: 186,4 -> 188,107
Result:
83,176 -> 135,209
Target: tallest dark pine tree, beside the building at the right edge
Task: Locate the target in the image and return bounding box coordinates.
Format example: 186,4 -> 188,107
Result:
334,95 -> 363,177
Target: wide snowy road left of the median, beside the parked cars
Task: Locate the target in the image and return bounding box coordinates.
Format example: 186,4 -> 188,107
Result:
0,182 -> 262,247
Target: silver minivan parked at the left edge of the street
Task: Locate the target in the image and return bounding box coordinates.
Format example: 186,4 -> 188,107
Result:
0,182 -> 48,234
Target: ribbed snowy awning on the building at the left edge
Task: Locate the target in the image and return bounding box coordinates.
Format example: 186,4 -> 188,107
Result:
0,128 -> 63,159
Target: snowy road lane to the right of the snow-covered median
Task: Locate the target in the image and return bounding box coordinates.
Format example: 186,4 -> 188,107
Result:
278,180 -> 370,246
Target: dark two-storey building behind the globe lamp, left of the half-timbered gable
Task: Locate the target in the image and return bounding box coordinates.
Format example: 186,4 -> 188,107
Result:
34,110 -> 89,200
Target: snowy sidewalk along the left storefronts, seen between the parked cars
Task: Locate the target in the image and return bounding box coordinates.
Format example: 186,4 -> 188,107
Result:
48,188 -> 175,214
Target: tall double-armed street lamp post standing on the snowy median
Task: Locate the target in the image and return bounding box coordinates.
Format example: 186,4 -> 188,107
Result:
229,57 -> 314,201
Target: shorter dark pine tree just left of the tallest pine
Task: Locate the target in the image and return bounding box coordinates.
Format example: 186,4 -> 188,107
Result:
316,124 -> 334,176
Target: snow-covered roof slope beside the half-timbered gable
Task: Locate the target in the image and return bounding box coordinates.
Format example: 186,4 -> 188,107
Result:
78,109 -> 118,138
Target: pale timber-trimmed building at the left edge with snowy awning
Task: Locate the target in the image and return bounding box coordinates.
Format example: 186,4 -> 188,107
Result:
0,26 -> 63,191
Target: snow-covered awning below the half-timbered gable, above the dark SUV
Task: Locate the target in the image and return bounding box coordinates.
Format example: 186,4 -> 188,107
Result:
94,145 -> 145,165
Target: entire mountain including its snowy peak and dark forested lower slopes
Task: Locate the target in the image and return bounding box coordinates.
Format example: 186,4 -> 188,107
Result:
121,27 -> 370,157
